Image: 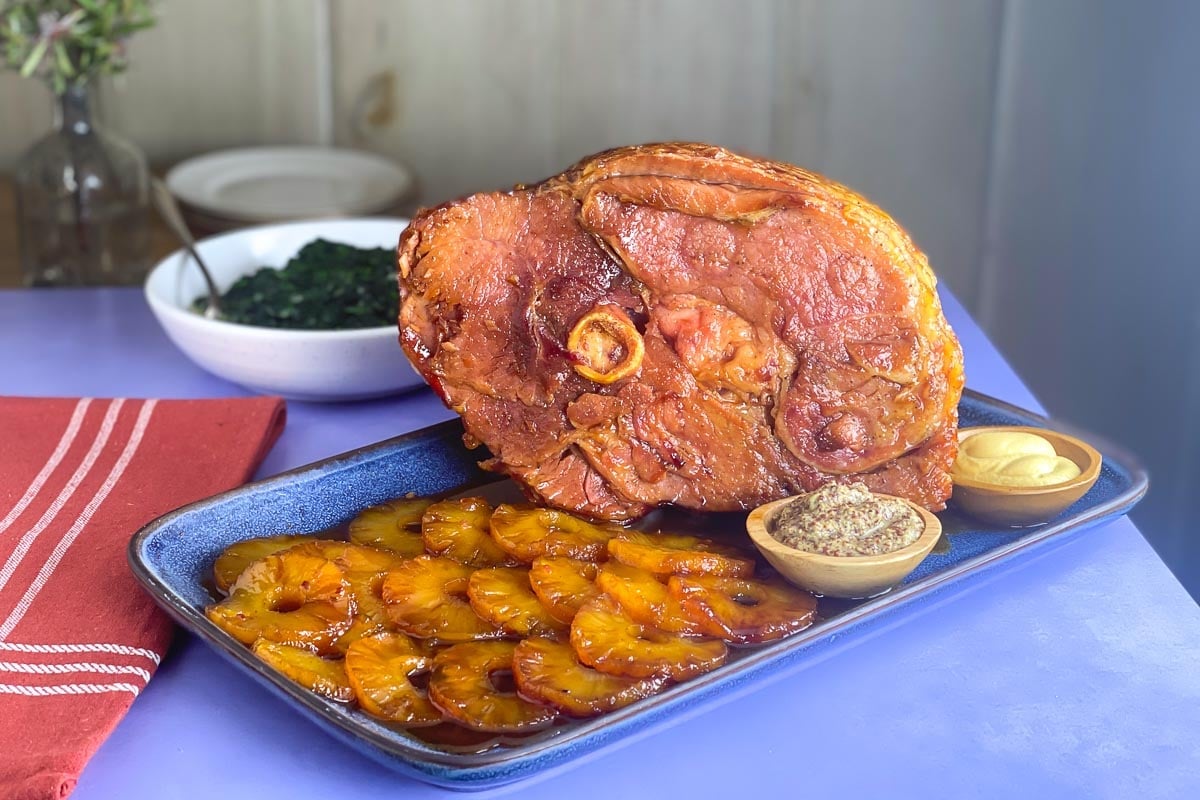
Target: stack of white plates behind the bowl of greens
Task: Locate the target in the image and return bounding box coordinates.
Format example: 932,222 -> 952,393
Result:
167,148 -> 415,231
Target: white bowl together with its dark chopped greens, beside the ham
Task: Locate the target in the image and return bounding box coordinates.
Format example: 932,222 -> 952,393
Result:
145,217 -> 425,402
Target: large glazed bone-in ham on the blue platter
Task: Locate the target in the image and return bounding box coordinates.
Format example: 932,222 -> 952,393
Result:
398,144 -> 962,519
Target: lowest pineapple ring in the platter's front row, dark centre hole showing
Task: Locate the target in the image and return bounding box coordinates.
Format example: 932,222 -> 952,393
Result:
430,642 -> 558,733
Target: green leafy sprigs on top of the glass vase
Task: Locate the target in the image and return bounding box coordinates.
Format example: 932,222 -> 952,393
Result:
0,0 -> 155,95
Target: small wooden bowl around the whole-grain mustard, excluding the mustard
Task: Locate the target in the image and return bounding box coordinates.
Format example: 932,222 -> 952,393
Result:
746,494 -> 942,597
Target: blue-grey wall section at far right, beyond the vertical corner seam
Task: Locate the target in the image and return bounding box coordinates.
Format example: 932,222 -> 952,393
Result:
976,0 -> 1200,587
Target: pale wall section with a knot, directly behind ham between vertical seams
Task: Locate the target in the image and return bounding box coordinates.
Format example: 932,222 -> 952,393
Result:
332,0 -> 1002,303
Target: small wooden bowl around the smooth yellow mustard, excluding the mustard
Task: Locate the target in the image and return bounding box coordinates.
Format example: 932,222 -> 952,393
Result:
952,425 -> 1103,527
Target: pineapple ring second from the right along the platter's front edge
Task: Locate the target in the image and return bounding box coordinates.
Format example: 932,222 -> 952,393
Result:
571,595 -> 727,680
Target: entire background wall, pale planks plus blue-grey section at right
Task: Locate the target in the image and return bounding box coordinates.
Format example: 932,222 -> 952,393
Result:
0,0 -> 1200,593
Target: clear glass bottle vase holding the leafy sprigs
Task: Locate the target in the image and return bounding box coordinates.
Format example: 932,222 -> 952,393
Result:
14,84 -> 150,287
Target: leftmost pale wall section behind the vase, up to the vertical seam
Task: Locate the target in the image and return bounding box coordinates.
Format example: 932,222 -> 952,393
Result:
0,0 -> 322,165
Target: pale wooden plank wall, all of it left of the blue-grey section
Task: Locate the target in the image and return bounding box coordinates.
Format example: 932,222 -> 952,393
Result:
0,0 -> 1003,303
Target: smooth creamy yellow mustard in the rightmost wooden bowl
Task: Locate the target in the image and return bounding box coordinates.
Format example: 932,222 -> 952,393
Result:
953,431 -> 1080,487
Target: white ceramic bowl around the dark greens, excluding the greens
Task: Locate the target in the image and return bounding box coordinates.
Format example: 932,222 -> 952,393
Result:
145,218 -> 424,401
